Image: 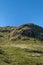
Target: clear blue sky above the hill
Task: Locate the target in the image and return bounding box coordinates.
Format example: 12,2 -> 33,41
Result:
0,0 -> 43,26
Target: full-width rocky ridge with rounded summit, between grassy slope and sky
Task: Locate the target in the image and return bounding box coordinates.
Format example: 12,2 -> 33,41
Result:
0,23 -> 43,40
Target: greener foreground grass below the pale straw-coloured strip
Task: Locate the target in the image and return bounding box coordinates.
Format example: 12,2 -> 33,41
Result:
0,43 -> 43,65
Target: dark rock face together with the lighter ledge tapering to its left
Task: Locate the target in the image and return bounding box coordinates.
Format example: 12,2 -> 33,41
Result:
13,28 -> 35,37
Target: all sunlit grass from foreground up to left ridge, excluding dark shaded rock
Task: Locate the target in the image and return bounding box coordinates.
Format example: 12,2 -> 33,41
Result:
0,26 -> 43,65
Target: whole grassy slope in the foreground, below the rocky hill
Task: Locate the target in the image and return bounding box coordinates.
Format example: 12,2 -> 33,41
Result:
0,38 -> 43,65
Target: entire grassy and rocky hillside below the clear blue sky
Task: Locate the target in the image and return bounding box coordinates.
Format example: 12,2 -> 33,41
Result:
0,24 -> 43,65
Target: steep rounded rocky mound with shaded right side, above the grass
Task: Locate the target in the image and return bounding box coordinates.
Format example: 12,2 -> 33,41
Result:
12,24 -> 43,39
